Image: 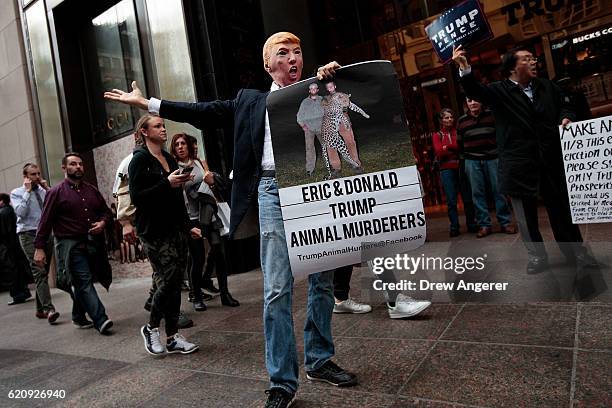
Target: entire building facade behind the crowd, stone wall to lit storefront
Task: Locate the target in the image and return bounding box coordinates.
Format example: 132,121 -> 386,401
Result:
0,0 -> 612,226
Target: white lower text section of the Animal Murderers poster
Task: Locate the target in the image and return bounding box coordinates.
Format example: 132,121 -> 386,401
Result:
280,166 -> 426,276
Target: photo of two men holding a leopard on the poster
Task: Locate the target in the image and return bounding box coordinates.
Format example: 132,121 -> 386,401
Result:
267,61 -> 415,188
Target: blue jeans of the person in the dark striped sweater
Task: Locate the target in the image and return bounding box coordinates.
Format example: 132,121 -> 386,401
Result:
465,159 -> 512,228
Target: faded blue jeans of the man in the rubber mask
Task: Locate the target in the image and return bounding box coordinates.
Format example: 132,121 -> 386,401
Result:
258,177 -> 334,393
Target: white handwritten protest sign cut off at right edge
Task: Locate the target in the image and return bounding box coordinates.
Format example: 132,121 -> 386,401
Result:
559,116 -> 612,224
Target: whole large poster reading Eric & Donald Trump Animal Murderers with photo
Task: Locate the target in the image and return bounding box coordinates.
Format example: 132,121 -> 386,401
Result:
267,61 -> 425,277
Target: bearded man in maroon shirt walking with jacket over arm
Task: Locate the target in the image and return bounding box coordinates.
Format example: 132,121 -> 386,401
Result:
34,152 -> 113,335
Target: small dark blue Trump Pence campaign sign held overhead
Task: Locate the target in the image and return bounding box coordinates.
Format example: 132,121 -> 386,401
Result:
425,0 -> 493,64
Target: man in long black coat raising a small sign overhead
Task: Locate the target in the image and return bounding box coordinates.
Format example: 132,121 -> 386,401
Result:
453,46 -> 592,274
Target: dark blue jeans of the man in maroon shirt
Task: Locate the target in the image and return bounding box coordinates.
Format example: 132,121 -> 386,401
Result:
70,248 -> 108,330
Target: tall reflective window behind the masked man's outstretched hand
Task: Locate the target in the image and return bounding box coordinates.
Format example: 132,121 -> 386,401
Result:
83,0 -> 145,145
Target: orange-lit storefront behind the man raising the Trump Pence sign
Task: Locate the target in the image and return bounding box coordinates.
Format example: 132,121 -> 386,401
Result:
366,0 -> 612,204
